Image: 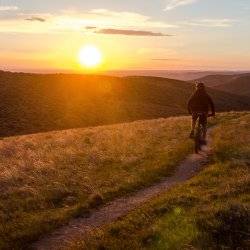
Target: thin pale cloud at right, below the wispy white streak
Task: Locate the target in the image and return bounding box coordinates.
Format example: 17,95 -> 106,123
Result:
183,18 -> 236,28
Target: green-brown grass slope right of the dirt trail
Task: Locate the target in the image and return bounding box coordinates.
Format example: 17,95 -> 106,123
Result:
72,113 -> 250,250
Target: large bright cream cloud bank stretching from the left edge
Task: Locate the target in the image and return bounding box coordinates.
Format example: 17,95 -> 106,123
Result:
0,9 -> 178,36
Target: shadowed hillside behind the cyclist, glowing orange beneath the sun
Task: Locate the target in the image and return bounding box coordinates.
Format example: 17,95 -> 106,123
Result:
0,72 -> 250,136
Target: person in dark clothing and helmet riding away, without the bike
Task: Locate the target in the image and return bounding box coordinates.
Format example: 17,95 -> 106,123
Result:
188,82 -> 215,144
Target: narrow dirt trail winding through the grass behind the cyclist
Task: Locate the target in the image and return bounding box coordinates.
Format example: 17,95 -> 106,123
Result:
31,137 -> 211,250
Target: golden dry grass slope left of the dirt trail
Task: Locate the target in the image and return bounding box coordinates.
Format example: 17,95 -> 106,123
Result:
0,117 -> 192,249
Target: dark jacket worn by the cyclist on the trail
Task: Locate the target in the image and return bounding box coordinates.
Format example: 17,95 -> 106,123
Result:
188,89 -> 215,115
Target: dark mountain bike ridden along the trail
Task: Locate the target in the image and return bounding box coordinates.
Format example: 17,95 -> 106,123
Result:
194,112 -> 212,154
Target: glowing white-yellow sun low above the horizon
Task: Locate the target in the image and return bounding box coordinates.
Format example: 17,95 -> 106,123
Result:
79,45 -> 102,68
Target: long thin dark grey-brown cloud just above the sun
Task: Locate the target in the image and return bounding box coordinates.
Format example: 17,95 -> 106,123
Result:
95,29 -> 171,36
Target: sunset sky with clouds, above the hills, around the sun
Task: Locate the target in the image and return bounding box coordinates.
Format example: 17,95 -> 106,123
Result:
0,0 -> 250,72
